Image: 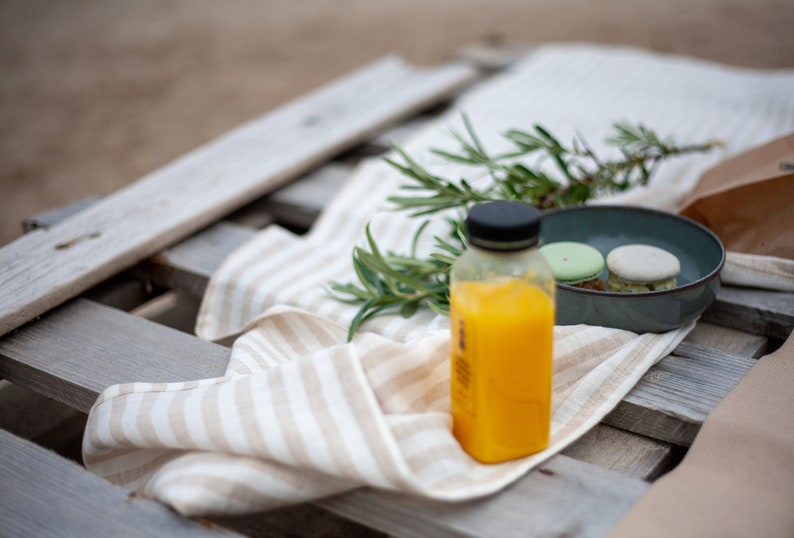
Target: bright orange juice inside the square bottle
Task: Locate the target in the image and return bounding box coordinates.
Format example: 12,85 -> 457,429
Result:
450,278 -> 554,463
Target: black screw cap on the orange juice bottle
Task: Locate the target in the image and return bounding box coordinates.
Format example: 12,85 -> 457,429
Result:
466,201 -> 540,251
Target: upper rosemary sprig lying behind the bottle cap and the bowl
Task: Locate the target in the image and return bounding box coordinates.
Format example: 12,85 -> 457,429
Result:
386,116 -> 722,216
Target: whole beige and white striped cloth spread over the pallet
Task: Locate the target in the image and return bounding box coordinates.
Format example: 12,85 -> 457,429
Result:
84,46 -> 794,515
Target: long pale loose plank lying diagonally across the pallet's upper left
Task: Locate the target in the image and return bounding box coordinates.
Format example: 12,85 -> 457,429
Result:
0,58 -> 476,334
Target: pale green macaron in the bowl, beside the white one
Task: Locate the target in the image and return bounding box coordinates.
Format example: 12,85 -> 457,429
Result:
540,241 -> 604,289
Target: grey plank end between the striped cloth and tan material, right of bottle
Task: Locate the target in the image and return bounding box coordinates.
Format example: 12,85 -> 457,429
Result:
604,342 -> 755,446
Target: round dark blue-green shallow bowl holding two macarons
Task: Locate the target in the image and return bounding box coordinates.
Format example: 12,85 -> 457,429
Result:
541,206 -> 725,333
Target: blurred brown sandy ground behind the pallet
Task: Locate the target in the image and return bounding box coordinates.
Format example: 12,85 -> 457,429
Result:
0,0 -> 794,245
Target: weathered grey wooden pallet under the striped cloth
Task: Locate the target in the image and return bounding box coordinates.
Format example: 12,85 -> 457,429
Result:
0,46 -> 794,536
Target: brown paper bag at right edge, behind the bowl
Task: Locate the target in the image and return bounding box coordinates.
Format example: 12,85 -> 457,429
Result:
679,134 -> 794,259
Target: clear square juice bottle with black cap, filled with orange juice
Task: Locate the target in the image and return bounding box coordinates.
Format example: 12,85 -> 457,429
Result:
450,202 -> 555,463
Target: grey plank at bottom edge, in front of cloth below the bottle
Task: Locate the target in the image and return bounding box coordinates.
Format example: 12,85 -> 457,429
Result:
318,456 -> 648,538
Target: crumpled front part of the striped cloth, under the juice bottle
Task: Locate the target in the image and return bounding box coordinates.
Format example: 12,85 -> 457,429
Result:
83,307 -> 692,515
